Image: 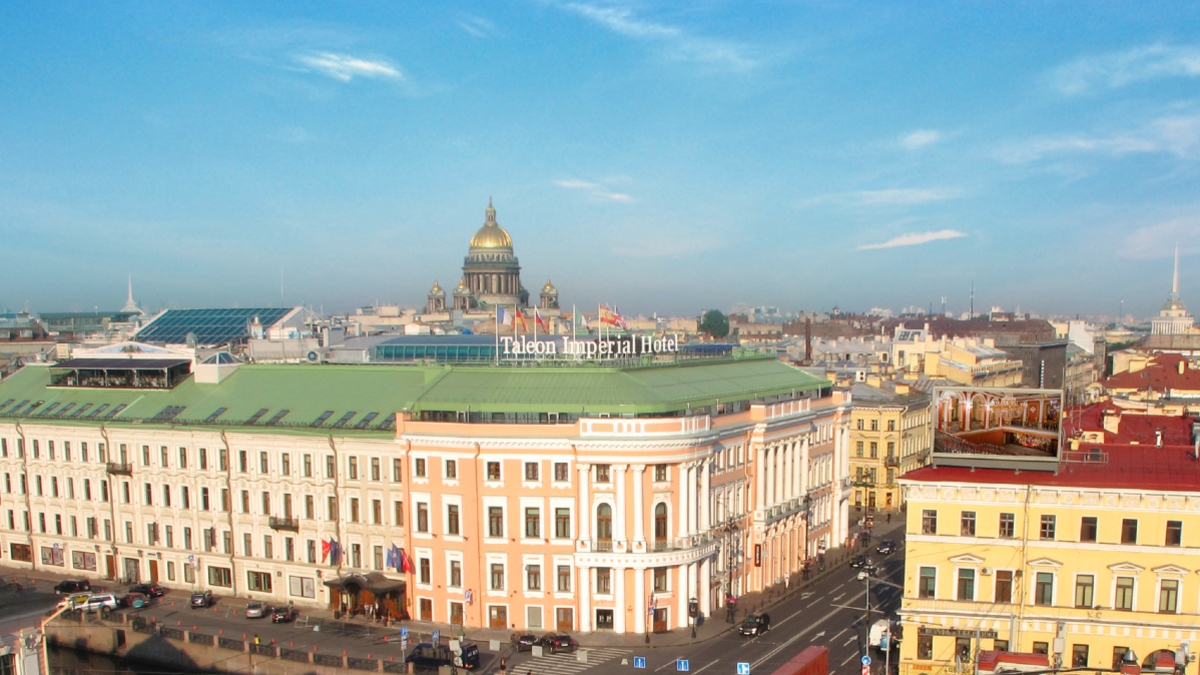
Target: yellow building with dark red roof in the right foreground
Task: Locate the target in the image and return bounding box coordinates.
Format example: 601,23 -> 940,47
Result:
900,443 -> 1200,675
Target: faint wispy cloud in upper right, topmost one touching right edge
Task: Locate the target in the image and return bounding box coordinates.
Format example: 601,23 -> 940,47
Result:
1050,43 -> 1200,95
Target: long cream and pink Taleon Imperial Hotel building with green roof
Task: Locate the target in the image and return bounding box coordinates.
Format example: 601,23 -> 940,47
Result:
0,346 -> 851,633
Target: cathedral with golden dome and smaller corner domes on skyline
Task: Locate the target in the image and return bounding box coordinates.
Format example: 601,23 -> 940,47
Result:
426,199 -> 558,313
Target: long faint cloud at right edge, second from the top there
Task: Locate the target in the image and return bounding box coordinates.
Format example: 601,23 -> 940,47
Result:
996,115 -> 1200,163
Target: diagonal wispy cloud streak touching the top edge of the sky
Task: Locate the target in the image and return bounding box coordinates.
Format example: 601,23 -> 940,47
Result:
560,2 -> 761,72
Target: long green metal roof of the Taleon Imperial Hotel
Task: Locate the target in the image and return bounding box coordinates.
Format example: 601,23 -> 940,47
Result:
0,359 -> 830,434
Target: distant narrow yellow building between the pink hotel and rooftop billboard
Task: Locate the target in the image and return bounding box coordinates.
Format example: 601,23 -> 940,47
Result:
850,378 -> 931,510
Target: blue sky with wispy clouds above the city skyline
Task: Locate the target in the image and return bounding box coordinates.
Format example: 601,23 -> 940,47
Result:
0,0 -> 1200,316
